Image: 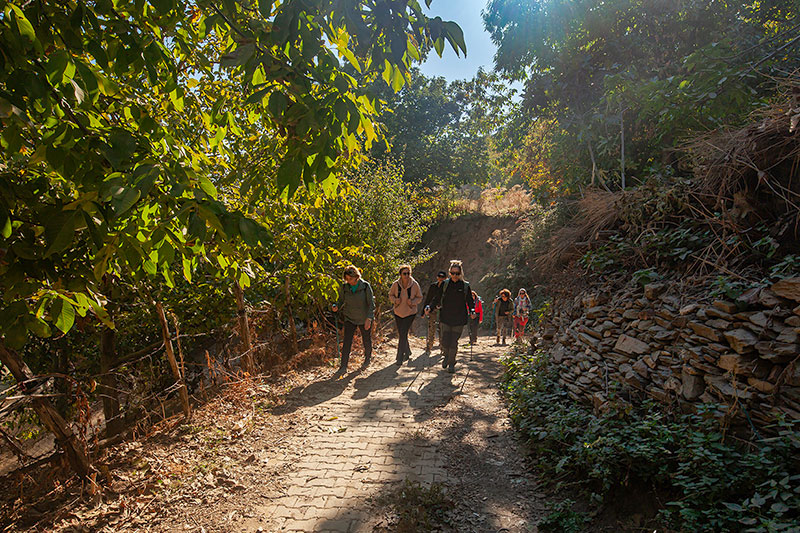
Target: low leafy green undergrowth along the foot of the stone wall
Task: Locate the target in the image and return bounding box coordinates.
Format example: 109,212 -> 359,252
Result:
504,352 -> 800,532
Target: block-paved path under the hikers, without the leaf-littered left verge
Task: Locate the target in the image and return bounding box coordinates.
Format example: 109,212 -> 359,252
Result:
242,338 -> 539,532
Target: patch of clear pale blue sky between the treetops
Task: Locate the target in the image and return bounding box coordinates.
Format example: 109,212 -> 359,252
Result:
420,0 -> 496,81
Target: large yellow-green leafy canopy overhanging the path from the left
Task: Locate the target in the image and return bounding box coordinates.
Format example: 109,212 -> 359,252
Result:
0,0 -> 465,347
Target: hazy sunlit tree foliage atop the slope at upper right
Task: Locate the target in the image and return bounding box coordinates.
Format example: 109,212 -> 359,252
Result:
484,0 -> 800,194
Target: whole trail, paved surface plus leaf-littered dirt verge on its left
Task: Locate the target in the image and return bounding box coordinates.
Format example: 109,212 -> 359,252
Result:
78,337 -> 544,533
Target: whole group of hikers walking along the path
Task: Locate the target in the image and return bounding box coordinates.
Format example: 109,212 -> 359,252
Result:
332,260 -> 532,376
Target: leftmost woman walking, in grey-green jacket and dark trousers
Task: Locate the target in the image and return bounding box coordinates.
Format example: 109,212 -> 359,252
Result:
333,265 -> 375,376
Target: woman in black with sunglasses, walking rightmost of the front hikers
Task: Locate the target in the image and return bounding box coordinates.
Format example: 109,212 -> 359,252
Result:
439,260 -> 477,374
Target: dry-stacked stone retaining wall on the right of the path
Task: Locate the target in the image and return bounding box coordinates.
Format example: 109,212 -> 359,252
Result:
539,278 -> 800,428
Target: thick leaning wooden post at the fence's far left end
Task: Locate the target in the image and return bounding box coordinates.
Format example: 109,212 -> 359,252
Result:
0,344 -> 90,478
